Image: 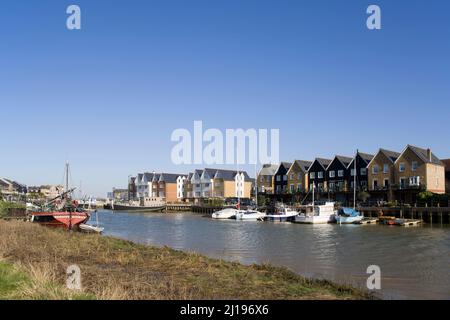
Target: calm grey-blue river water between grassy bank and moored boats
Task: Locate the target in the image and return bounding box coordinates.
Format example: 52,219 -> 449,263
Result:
93,211 -> 450,299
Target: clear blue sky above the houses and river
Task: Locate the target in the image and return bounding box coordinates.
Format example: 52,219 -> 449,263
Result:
0,0 -> 450,196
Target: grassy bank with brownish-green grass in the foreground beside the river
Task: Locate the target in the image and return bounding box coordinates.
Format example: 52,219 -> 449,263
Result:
0,221 -> 370,299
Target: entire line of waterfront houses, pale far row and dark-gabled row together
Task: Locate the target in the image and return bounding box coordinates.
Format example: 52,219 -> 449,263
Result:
122,145 -> 450,203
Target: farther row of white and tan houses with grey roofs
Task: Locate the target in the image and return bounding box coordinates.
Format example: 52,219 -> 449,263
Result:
128,168 -> 254,203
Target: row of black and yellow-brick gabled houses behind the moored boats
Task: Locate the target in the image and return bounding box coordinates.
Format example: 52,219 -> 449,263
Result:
257,145 -> 450,201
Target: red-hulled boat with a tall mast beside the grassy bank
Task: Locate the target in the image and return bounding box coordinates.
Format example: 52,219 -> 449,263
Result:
30,162 -> 90,230
